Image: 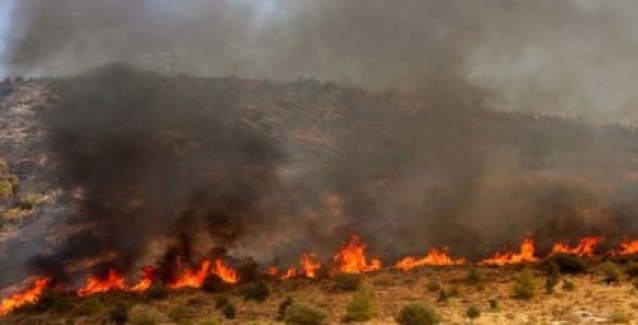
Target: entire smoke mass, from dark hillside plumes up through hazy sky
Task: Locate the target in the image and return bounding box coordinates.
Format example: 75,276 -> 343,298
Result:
5,0 -> 638,280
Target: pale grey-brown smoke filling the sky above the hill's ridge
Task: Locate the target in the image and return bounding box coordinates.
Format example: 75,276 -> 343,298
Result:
5,0 -> 638,123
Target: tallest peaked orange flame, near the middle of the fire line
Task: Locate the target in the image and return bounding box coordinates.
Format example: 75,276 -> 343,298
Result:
332,235 -> 381,273
